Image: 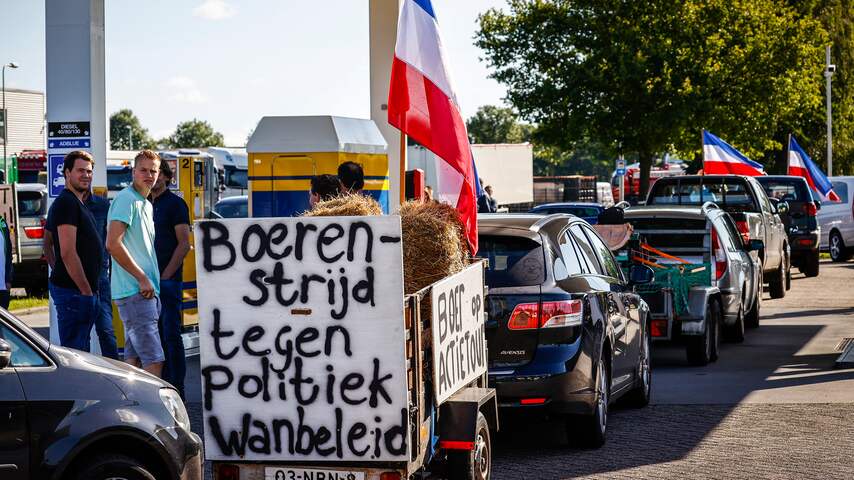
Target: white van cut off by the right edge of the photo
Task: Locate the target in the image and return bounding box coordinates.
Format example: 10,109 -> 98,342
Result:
818,177 -> 854,262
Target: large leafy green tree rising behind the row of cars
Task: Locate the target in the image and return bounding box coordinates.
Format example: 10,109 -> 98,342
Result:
476,0 -> 824,195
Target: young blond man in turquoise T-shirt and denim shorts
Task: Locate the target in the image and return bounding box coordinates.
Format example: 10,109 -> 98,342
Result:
107,150 -> 165,377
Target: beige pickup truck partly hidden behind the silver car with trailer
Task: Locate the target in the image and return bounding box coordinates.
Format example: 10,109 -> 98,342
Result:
646,175 -> 791,298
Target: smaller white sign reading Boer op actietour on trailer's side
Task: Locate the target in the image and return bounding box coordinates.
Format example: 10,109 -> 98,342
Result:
430,262 -> 487,403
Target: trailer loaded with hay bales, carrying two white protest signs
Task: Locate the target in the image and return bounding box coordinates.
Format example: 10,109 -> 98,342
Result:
194,196 -> 498,480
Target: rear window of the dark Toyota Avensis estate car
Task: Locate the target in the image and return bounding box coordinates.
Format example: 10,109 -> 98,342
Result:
477,235 -> 546,288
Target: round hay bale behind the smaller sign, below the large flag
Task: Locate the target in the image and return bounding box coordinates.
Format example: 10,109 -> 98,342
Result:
400,202 -> 468,294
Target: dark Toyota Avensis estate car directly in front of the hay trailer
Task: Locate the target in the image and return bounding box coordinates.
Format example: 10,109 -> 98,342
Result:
478,214 -> 653,446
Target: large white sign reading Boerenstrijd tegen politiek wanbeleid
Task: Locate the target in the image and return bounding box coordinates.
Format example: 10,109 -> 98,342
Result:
194,216 -> 409,462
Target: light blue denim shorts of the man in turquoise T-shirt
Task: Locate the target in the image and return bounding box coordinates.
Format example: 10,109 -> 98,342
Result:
115,293 -> 166,367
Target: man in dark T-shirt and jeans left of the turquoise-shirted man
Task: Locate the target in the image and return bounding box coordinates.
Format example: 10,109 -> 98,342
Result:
48,151 -> 104,352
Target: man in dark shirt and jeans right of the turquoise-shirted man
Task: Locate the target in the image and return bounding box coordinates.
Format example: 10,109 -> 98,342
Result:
148,162 -> 190,398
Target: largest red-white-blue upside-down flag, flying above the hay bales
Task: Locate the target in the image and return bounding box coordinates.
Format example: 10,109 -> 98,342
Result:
388,0 -> 477,255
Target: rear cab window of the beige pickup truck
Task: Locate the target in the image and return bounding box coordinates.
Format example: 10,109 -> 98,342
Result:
647,177 -> 759,212
